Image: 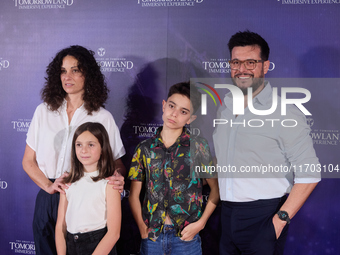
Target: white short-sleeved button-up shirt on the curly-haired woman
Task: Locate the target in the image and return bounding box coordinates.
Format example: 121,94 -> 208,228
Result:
26,100 -> 125,179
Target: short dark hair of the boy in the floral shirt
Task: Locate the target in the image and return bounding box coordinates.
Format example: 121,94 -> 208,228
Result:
168,82 -> 201,114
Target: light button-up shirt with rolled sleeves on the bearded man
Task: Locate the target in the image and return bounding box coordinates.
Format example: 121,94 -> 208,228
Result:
213,83 -> 320,202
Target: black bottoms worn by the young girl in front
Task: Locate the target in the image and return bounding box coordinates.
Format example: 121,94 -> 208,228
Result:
66,228 -> 117,255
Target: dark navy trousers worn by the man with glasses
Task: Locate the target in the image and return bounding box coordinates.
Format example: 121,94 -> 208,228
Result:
220,196 -> 288,255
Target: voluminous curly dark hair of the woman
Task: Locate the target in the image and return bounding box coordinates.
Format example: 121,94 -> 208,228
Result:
41,45 -> 109,115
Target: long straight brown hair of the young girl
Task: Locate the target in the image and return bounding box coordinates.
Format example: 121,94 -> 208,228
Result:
64,122 -> 115,183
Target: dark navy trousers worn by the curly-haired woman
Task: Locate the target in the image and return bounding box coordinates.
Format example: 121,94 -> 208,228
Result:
33,187 -> 59,255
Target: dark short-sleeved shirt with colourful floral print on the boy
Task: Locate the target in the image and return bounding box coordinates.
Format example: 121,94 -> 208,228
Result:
128,127 -> 212,241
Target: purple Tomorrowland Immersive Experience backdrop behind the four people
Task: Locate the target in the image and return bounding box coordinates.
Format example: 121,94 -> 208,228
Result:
0,0 -> 340,255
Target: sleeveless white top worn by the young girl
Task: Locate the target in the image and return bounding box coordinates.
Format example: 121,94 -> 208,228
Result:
65,171 -> 108,234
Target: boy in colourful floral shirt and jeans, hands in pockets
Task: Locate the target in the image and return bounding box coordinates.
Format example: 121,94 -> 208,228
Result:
129,83 -> 219,255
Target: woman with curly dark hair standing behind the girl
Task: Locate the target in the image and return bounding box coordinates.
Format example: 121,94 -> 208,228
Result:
22,45 -> 125,255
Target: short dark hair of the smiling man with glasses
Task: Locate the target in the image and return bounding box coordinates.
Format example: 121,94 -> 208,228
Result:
228,30 -> 270,61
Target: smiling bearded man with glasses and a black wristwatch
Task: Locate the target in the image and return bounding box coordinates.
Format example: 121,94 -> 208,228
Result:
213,31 -> 320,255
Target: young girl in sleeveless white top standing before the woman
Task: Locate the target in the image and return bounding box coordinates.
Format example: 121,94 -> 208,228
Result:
55,122 -> 121,255
